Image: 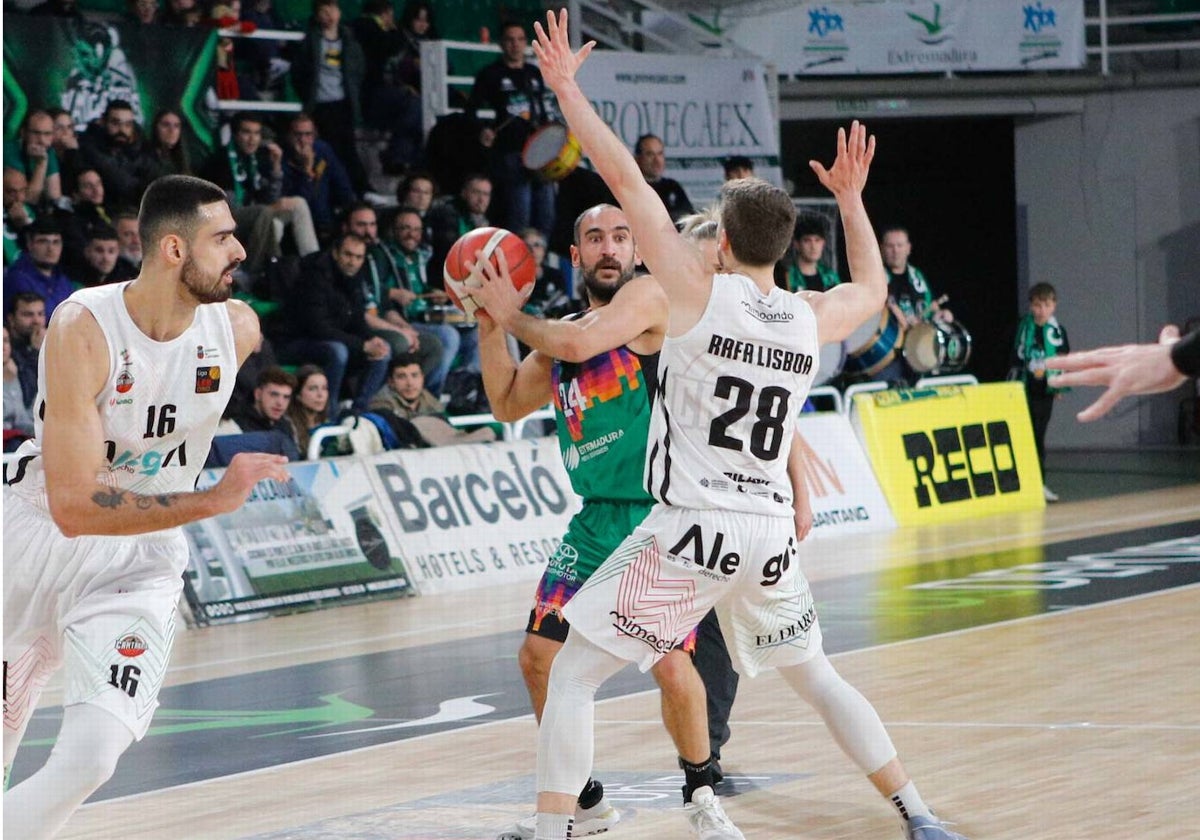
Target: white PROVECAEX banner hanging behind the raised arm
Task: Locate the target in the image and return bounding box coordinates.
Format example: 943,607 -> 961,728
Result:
578,50 -> 782,210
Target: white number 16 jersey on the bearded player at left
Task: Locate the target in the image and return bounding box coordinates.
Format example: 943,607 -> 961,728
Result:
7,283 -> 238,508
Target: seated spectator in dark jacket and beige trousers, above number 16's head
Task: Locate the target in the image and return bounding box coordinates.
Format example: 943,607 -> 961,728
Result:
205,113 -> 320,277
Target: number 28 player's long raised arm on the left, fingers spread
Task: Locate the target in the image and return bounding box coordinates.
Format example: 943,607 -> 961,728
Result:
533,8 -> 713,311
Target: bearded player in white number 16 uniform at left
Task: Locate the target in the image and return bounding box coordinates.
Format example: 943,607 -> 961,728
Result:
4,175 -> 288,840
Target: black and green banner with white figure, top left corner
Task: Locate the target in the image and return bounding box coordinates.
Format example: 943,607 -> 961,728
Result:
4,14 -> 216,154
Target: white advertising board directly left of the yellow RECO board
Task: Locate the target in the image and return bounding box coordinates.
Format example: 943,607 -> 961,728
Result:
799,412 -> 896,538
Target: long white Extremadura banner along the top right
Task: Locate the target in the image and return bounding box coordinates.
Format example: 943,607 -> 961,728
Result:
725,0 -> 1087,76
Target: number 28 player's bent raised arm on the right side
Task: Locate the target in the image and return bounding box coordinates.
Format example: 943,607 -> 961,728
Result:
802,120 -> 888,344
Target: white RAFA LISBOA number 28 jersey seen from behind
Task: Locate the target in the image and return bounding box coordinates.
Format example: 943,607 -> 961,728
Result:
646,274 -> 818,516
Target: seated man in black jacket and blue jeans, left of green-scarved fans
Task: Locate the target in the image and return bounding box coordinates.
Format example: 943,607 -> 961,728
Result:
278,234 -> 391,412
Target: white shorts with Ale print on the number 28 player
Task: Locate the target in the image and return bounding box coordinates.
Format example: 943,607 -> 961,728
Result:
564,505 -> 821,677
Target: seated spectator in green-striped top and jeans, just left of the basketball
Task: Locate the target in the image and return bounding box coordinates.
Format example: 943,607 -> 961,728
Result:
383,208 -> 468,394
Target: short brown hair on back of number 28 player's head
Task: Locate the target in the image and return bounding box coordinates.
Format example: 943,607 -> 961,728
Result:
720,178 -> 796,265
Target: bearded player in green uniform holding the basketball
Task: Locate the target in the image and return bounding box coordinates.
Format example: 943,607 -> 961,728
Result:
472,204 -> 734,840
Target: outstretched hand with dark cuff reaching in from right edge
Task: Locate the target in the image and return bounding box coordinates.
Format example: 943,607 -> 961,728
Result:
1046,325 -> 1200,422
